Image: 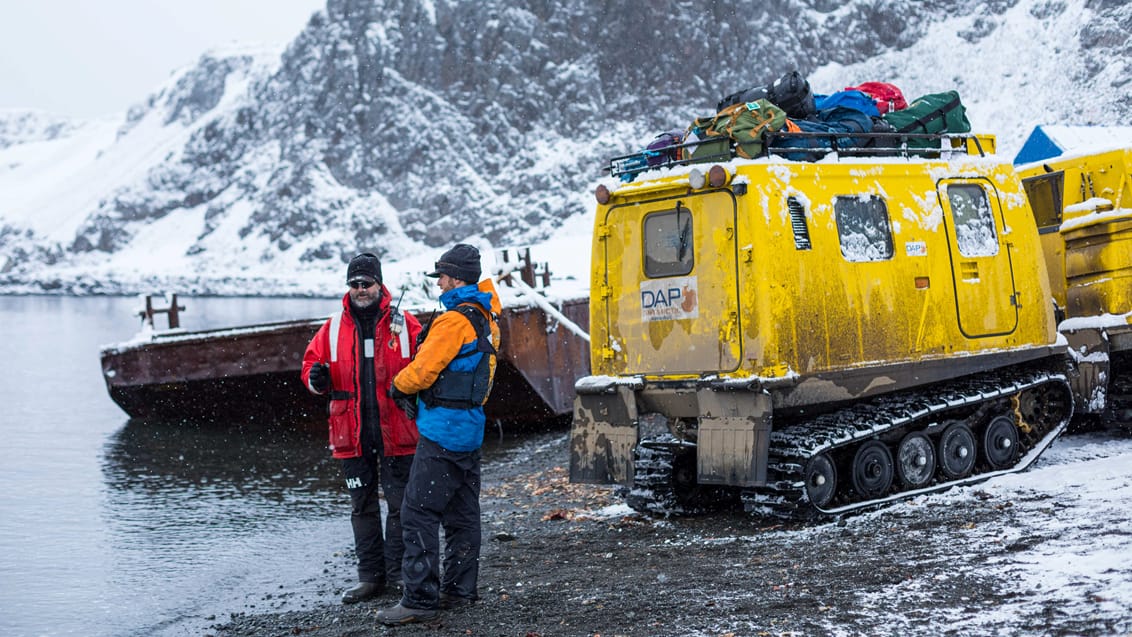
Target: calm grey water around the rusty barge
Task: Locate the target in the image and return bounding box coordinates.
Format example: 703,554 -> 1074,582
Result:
0,296 -> 352,636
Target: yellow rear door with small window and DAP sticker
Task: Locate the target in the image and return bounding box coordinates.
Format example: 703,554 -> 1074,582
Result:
604,190 -> 741,375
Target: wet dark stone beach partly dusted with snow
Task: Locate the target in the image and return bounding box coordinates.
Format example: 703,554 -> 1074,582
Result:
207,429 -> 1132,637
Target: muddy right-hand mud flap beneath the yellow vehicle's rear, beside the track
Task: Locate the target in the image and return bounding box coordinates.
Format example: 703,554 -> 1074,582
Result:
696,389 -> 772,487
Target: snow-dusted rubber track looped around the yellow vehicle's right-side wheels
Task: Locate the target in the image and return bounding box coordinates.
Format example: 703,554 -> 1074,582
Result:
743,368 -> 1073,519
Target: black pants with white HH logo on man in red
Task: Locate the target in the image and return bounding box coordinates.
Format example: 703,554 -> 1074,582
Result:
342,454 -> 413,584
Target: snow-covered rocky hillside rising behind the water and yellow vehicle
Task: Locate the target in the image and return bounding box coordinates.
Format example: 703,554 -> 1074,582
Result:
0,0 -> 1132,294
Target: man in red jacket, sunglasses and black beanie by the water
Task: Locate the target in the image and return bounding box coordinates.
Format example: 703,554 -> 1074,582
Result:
302,252 -> 421,604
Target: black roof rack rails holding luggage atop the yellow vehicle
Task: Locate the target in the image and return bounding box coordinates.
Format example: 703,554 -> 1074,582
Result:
602,131 -> 989,181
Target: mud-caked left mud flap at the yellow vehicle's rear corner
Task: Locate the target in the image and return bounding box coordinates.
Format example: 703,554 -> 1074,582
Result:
569,387 -> 637,485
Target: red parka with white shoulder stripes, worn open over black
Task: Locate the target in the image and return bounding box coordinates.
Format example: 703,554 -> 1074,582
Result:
302,285 -> 421,458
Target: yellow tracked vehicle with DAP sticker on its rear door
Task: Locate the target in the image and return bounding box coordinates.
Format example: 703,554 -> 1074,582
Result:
571,136 -> 1082,517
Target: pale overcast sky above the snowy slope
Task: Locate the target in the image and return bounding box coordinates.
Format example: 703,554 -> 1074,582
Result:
0,0 -> 326,118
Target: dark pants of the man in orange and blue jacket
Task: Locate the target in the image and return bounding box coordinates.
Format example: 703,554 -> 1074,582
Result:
401,437 -> 480,609
